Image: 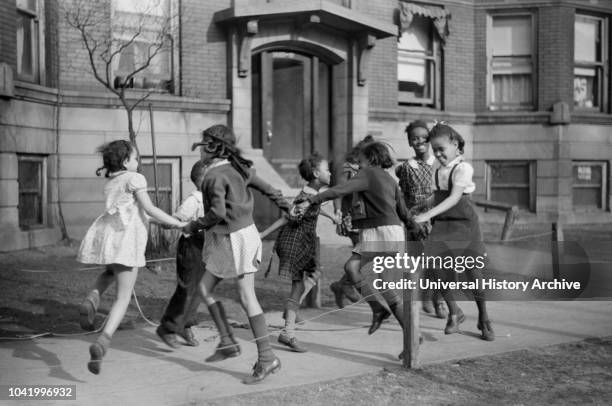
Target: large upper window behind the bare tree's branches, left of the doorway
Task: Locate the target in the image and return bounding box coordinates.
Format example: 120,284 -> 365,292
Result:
112,0 -> 175,93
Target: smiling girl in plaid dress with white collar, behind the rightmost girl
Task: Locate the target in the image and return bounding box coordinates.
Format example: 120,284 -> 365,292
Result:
395,120 -> 447,319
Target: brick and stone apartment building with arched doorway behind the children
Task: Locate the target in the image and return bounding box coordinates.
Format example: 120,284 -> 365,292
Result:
0,0 -> 612,251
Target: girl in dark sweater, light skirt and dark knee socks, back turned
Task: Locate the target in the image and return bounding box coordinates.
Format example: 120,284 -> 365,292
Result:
185,125 -> 290,384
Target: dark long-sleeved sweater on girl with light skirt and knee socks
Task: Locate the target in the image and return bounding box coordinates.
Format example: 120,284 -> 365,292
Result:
187,162 -> 291,234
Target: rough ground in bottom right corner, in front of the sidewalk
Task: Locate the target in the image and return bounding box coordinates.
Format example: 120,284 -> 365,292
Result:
208,338 -> 612,406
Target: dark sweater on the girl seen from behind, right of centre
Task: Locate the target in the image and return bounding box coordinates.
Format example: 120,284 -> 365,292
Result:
306,167 -> 411,229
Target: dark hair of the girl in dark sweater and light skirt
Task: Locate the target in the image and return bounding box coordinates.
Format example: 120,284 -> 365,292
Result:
201,124 -> 253,179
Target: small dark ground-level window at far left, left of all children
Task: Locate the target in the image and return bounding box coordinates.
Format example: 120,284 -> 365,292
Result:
18,155 -> 47,229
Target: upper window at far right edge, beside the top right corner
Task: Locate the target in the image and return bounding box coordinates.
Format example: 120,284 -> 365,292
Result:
574,14 -> 608,111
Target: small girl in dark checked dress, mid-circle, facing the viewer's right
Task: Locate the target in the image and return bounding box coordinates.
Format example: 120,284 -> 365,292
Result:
274,153 -> 340,352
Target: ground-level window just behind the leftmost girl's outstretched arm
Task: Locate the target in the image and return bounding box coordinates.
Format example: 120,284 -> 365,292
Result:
140,157 -> 181,214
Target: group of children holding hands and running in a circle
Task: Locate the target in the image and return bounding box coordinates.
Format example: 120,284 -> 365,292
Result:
77,121 -> 494,384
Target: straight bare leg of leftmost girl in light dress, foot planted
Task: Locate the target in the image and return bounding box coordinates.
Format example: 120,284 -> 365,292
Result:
87,264 -> 138,375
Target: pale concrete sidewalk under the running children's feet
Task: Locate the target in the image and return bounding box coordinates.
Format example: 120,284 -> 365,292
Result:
0,301 -> 612,405
